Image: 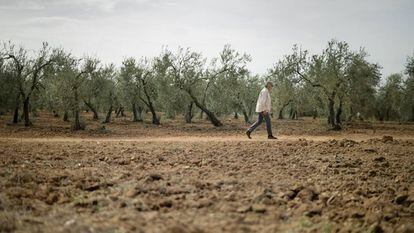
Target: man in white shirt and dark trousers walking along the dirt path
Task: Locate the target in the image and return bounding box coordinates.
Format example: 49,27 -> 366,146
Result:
246,82 -> 277,139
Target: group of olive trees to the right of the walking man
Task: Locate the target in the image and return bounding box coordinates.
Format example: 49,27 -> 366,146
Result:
269,40 -> 414,129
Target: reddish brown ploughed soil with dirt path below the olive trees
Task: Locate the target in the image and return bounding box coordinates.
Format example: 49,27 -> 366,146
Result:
0,114 -> 414,232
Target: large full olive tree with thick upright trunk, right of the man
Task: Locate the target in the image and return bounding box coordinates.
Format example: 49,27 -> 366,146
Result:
280,40 -> 379,129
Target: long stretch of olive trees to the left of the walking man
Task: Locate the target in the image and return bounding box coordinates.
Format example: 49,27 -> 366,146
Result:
0,43 -> 261,130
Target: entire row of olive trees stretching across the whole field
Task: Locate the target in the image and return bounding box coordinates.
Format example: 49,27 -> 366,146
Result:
0,40 -> 414,130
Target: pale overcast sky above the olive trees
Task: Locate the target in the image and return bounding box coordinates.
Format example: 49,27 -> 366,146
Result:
0,0 -> 414,76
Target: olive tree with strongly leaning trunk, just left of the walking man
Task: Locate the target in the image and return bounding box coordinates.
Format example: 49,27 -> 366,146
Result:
162,45 -> 250,126
